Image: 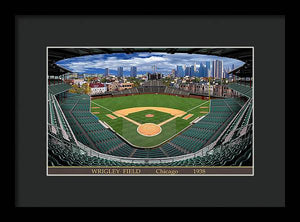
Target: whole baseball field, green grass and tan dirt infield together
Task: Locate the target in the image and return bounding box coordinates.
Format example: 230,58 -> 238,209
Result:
91,94 -> 209,148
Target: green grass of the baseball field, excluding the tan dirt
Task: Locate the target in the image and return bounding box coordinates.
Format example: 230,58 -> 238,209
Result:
91,94 -> 209,147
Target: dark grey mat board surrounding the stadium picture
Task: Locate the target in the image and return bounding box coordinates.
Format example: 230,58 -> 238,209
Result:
11,10 -> 285,207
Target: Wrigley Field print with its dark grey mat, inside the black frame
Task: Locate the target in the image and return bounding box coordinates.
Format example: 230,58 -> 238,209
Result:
14,13 -> 287,207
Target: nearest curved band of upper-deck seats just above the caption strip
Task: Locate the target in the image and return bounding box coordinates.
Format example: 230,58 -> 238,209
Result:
48,126 -> 252,166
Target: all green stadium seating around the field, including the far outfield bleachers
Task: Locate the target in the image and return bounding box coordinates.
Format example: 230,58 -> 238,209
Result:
48,46 -> 253,172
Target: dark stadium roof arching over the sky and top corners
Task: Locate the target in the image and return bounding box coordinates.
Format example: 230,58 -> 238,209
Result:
48,47 -> 252,77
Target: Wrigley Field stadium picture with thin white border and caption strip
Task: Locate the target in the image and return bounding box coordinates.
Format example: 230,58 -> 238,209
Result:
46,46 -> 254,176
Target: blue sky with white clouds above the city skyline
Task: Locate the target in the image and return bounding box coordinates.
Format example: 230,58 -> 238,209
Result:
56,52 -> 244,75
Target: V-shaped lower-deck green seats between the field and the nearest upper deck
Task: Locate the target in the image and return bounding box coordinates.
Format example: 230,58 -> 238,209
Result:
49,89 -> 249,164
